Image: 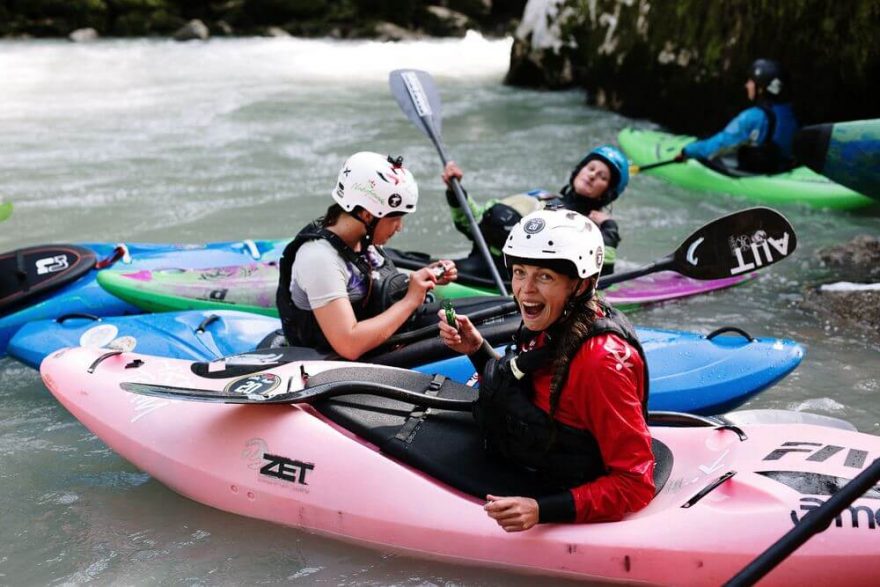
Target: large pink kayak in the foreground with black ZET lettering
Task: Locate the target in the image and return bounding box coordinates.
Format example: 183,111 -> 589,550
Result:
41,348 -> 880,585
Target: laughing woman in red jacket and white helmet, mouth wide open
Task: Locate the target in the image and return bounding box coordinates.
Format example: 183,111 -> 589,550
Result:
440,210 -> 654,532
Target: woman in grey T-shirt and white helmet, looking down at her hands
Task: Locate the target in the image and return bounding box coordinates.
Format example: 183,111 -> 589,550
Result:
276,151 -> 457,360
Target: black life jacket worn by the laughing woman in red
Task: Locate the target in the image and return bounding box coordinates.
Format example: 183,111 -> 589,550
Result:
474,304 -> 648,489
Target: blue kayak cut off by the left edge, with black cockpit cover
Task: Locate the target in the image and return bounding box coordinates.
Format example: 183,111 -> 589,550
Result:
0,240 -> 287,357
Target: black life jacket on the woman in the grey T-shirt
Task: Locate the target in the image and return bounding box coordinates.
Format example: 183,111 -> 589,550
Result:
275,221 -> 407,352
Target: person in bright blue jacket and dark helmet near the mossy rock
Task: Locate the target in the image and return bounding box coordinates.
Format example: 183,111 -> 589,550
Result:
679,59 -> 798,174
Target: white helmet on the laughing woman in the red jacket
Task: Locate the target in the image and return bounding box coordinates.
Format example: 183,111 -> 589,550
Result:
503,209 -> 605,279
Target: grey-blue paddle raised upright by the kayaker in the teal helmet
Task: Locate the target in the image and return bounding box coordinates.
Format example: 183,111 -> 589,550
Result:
388,69 -> 507,296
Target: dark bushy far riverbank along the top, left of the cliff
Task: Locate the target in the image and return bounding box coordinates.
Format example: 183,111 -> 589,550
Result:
0,0 -> 525,38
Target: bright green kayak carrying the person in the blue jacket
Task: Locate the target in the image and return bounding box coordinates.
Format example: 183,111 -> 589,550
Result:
618,128 -> 874,210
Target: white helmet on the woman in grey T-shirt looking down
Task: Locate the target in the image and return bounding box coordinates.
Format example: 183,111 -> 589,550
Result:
330,151 -> 419,218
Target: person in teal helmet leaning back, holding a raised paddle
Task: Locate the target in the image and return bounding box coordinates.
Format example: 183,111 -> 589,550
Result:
442,145 -> 629,275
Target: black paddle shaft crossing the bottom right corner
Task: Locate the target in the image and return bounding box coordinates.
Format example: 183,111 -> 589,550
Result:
724,459 -> 880,587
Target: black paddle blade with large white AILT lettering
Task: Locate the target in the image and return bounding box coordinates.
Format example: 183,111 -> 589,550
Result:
670,207 -> 797,279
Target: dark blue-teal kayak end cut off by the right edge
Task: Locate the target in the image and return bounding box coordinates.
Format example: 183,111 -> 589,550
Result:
794,118 -> 880,200
